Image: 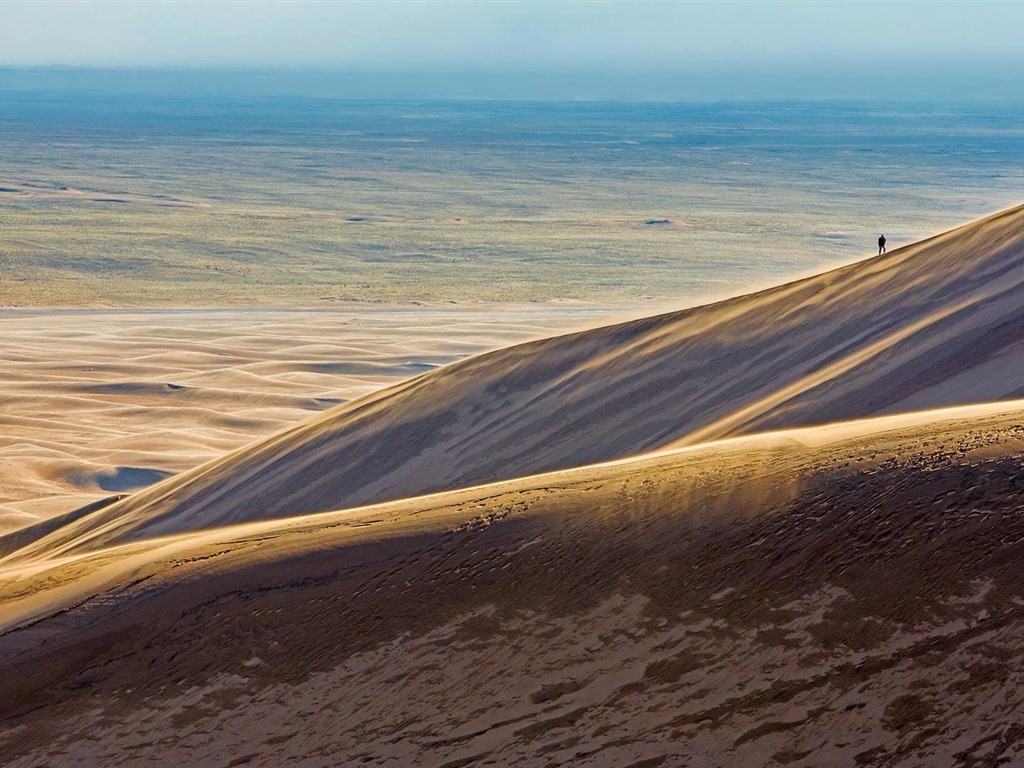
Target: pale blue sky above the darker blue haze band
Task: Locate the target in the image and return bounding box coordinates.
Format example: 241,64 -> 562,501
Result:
0,0 -> 1024,100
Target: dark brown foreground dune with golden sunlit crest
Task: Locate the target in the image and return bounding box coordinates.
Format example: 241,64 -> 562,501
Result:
6,402 -> 1024,768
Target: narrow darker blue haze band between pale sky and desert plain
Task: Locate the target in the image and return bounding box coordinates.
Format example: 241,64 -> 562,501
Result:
0,61 -> 1024,104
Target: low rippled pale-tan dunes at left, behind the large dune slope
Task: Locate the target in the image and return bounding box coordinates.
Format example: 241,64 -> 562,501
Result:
0,306 -> 590,532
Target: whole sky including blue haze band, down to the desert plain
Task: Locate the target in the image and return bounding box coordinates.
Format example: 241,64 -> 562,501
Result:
0,0 -> 1024,101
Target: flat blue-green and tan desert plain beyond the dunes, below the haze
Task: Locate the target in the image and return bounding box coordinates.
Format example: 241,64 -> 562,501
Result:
0,97 -> 1024,313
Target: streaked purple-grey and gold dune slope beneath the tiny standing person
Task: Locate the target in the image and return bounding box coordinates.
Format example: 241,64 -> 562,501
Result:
12,202 -> 1024,555
